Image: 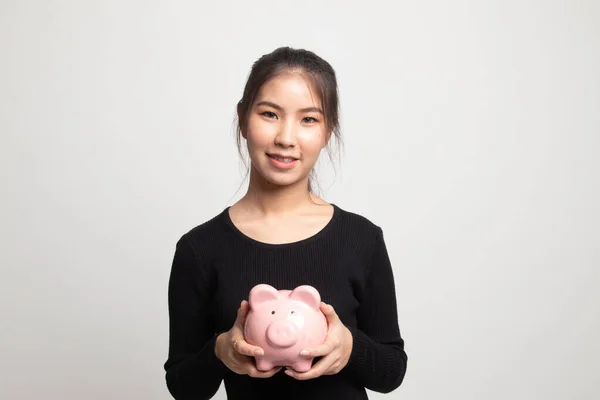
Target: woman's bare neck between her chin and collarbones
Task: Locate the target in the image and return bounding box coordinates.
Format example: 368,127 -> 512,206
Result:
241,169 -> 322,214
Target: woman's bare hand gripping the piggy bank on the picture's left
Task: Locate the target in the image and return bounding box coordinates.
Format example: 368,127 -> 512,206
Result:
215,300 -> 281,378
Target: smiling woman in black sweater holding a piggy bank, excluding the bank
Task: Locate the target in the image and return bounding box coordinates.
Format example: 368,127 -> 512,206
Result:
165,47 -> 407,400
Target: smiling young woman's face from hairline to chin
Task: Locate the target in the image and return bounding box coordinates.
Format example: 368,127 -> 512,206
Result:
243,73 -> 329,189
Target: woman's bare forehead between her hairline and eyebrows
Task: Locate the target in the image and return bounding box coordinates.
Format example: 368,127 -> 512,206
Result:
257,72 -> 321,108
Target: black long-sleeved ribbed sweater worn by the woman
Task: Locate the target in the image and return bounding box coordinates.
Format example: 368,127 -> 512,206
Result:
164,205 -> 407,400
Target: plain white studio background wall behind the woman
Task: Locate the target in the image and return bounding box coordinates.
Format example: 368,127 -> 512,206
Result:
0,0 -> 600,400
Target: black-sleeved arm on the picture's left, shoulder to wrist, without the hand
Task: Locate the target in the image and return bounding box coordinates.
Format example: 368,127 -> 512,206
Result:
164,236 -> 228,400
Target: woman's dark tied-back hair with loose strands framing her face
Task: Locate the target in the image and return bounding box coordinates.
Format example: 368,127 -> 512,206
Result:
236,47 -> 341,192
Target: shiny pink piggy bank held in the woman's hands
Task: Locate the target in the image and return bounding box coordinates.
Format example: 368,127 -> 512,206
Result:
244,284 -> 327,372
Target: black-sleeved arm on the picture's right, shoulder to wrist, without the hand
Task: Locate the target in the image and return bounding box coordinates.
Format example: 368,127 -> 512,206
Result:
344,229 -> 407,393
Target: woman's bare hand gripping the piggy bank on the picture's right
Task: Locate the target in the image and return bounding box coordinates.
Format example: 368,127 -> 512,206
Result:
285,303 -> 352,380
